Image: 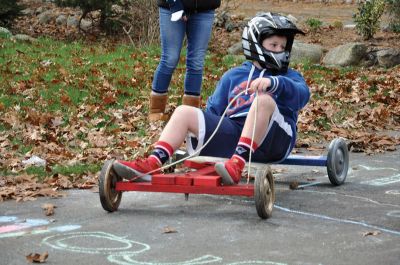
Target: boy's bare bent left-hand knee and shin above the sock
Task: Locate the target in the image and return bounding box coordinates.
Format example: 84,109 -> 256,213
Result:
159,105 -> 199,150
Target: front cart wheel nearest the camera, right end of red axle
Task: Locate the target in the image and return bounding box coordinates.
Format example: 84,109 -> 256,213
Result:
254,166 -> 275,219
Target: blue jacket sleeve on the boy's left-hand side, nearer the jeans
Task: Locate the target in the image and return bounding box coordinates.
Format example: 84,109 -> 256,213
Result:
206,73 -> 231,116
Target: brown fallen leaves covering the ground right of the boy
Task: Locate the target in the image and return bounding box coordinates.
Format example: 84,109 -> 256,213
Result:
297,67 -> 400,154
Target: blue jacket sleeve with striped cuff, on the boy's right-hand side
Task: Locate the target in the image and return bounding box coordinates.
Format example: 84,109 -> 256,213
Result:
268,70 -> 310,111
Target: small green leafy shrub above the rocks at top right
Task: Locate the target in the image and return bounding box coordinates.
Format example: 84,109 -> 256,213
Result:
354,0 -> 385,40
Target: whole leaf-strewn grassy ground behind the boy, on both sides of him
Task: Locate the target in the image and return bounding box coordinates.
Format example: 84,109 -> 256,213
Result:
0,34 -> 400,201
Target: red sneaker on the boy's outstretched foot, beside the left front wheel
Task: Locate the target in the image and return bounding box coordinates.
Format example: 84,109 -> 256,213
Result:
113,158 -> 160,181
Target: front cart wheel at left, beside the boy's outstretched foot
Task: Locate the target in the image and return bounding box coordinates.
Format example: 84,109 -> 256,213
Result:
99,160 -> 122,212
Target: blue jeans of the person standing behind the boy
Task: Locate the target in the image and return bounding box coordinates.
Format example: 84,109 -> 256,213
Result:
152,8 -> 214,95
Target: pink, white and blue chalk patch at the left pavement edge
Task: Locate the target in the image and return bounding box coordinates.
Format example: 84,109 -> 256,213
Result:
0,216 -> 81,239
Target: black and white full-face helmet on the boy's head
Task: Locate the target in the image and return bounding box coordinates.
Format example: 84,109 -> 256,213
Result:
242,12 -> 304,74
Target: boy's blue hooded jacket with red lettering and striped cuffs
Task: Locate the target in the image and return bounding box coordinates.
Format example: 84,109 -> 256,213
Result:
206,61 -> 310,150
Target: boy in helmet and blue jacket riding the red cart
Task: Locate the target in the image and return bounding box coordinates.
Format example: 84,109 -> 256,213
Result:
113,13 -> 310,185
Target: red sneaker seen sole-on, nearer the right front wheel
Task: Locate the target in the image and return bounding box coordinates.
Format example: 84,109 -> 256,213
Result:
215,158 -> 244,185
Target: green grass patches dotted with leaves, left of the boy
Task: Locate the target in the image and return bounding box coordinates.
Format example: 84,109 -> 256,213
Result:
0,38 -> 238,178
